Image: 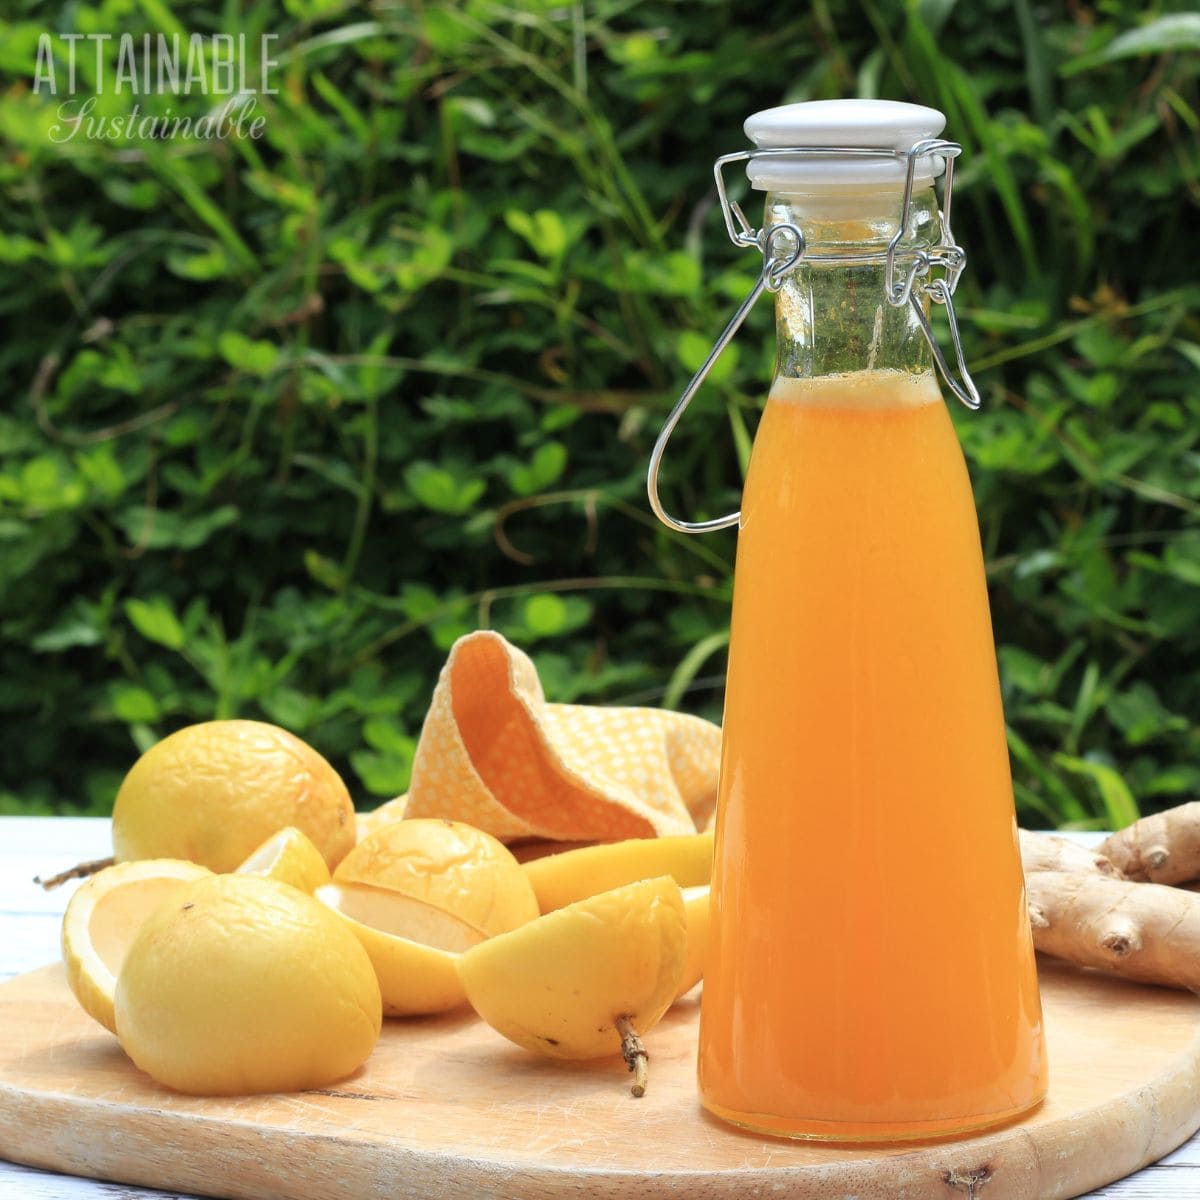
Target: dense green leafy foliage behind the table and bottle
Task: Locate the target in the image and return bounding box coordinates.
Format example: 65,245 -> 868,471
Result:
0,0 -> 1200,826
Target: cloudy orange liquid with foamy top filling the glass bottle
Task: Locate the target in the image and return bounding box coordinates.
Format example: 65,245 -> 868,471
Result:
700,371 -> 1046,1140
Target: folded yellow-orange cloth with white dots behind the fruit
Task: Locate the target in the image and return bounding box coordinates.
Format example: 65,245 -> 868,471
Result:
404,631 -> 721,841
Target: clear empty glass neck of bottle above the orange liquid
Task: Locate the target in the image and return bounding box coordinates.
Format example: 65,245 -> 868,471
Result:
766,187 -> 938,378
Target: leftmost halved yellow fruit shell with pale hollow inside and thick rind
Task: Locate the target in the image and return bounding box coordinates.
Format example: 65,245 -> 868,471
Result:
62,858 -> 212,1033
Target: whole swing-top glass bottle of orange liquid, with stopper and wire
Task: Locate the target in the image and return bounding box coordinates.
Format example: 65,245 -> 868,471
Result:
649,101 -> 1046,1140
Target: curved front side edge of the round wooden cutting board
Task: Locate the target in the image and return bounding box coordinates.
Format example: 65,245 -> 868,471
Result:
7,965 -> 1200,1200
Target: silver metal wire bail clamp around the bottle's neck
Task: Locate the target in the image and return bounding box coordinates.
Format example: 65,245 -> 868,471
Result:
646,138 -> 982,533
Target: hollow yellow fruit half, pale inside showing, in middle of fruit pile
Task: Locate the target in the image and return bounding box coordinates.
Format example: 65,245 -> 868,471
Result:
313,883 -> 487,1016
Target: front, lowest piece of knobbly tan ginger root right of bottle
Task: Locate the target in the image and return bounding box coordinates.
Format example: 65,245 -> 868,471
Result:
1026,871 -> 1200,991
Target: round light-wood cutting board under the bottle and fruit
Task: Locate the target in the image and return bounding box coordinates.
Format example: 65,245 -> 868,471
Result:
0,964 -> 1200,1200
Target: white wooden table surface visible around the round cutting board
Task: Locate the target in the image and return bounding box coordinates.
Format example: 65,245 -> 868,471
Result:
0,817 -> 1200,1200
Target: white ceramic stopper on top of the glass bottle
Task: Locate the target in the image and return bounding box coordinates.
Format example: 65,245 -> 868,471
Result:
744,100 -> 946,193
